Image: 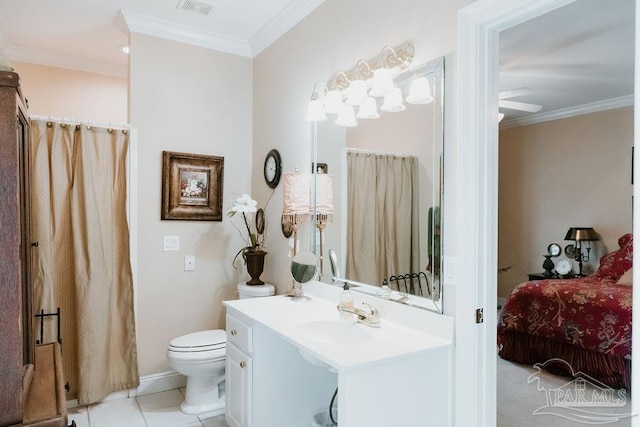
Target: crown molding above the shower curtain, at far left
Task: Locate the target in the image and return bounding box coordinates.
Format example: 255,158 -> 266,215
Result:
5,46 -> 129,78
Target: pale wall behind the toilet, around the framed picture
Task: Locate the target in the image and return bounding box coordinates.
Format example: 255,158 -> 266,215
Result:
130,34 -> 255,375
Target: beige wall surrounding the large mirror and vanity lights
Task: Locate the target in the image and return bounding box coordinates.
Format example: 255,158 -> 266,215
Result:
253,0 -> 471,310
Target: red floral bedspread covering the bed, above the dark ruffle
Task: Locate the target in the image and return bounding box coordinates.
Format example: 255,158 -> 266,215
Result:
498,275 -> 633,359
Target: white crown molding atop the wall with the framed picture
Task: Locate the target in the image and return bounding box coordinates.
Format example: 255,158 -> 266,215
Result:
119,10 -> 253,58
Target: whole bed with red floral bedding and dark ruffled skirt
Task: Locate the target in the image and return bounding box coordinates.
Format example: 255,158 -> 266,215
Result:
498,234 -> 633,390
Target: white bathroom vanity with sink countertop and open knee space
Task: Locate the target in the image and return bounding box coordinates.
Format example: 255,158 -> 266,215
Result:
224,281 -> 454,427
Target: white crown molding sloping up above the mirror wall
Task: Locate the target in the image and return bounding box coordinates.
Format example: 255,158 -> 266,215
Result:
249,0 -> 324,56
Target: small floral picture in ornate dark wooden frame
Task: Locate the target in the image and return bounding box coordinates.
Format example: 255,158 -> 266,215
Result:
161,151 -> 224,221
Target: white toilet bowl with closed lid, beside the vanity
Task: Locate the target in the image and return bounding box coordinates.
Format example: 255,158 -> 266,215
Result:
167,329 -> 227,415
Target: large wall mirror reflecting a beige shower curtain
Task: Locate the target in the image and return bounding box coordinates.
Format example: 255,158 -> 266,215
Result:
312,57 -> 445,313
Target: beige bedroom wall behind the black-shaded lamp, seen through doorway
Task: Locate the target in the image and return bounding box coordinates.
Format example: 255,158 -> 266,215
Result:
498,107 -> 633,297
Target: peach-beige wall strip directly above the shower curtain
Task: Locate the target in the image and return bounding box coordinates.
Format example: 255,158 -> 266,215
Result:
12,62 -> 128,124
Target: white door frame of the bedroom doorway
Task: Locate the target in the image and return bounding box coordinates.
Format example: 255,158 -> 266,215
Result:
454,0 -> 640,427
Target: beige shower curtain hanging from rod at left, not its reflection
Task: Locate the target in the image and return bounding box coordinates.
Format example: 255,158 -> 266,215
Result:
31,120 -> 139,404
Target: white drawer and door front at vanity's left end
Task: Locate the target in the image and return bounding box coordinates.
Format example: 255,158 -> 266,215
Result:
225,315 -> 253,427
